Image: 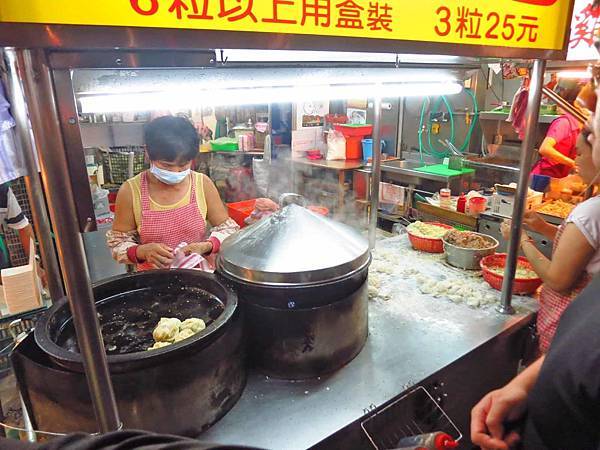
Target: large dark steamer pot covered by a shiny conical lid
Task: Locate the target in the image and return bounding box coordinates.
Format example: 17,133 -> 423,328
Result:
217,205 -> 371,379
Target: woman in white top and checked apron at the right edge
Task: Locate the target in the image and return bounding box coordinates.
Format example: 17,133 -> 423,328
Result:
501,130 -> 600,352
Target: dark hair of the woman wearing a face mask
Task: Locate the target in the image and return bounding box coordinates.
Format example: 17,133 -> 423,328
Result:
144,116 -> 200,162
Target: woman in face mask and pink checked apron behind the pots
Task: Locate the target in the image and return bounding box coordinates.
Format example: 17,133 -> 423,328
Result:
107,116 -> 239,270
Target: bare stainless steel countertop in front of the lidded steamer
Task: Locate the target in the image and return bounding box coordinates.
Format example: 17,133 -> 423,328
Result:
202,237 -> 535,450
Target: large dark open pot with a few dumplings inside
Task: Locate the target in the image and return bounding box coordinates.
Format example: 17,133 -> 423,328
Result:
27,270 -> 246,436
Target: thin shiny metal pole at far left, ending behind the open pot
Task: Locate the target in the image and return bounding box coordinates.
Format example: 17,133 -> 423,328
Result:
5,49 -> 65,301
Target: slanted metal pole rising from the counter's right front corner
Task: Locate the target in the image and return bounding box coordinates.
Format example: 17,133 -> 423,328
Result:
498,59 -> 546,314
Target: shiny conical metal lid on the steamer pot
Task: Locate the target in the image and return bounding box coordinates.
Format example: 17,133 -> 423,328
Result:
217,204 -> 370,285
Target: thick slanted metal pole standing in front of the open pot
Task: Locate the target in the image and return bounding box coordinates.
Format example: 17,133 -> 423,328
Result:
17,50 -> 120,432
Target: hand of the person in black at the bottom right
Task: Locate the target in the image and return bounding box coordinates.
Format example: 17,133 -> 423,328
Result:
471,380 -> 528,450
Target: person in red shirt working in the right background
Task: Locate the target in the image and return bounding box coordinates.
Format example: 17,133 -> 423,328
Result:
531,85 -> 583,178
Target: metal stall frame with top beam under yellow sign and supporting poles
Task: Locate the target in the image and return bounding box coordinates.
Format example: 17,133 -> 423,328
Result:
0,13 -> 573,432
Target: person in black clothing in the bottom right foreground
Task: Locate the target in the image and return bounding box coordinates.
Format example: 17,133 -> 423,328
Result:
471,276 -> 600,450
